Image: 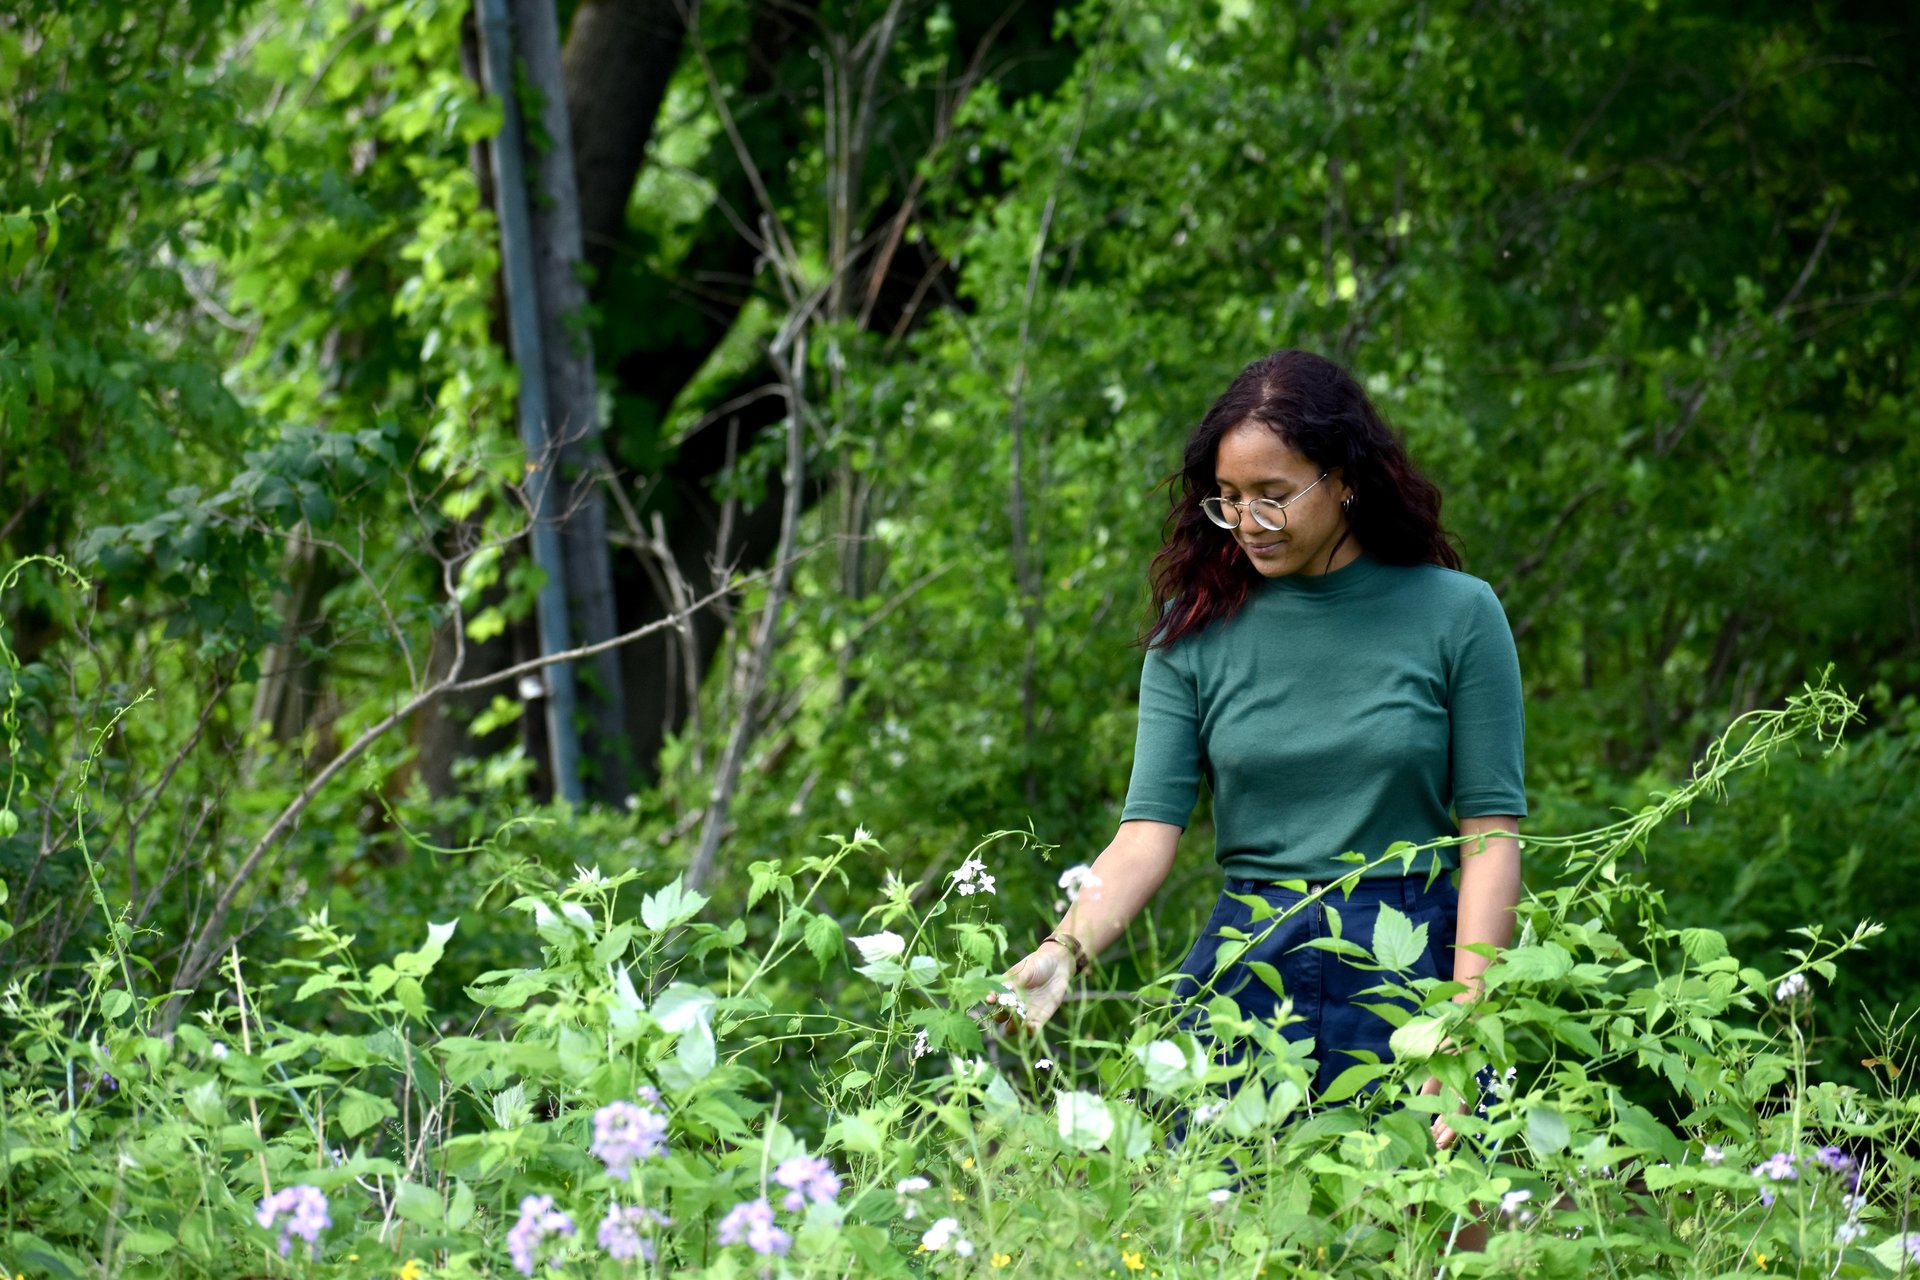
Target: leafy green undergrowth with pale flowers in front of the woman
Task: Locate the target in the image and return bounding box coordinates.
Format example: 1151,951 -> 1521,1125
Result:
0,675 -> 1920,1276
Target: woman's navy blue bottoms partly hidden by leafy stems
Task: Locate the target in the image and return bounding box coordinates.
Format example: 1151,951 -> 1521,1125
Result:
1173,873 -> 1459,1094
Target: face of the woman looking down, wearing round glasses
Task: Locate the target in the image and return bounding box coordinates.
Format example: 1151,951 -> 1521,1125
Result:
1213,420 -> 1359,578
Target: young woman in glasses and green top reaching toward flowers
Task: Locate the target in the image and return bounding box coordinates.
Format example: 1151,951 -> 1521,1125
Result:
1008,351 -> 1526,1146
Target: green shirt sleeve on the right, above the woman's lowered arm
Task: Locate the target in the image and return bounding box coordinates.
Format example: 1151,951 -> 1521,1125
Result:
1448,581 -> 1526,818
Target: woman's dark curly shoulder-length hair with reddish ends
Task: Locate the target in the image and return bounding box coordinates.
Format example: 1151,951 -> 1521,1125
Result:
1142,351 -> 1459,649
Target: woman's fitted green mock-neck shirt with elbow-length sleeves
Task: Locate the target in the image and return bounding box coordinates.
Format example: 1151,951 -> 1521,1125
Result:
1121,555 -> 1526,881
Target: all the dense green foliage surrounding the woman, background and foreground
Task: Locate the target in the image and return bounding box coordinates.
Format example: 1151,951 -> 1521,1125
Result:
0,0 -> 1920,1274
